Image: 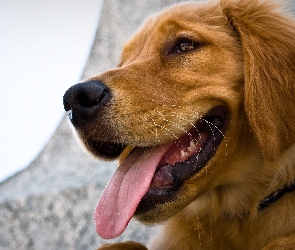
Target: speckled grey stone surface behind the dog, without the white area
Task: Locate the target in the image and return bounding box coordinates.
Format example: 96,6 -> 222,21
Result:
0,0 -> 185,250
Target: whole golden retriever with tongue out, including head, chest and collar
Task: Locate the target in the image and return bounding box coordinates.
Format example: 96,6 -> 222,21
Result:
63,0 -> 295,250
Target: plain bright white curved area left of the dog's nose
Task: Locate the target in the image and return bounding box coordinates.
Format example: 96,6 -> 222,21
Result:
0,0 -> 103,182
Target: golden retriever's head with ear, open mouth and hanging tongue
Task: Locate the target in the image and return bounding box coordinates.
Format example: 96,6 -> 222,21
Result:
64,0 -> 295,238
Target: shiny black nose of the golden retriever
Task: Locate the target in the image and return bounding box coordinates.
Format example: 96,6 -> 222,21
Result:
63,80 -> 111,125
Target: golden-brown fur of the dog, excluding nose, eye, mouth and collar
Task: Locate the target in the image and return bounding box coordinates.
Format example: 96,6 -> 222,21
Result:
78,0 -> 295,250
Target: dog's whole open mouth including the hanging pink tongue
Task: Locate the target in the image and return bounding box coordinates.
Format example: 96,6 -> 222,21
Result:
95,106 -> 228,239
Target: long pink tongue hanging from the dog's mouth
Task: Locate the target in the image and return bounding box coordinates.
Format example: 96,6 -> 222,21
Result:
94,147 -> 167,239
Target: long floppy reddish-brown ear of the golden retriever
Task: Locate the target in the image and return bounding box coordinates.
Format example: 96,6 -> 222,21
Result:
220,0 -> 295,160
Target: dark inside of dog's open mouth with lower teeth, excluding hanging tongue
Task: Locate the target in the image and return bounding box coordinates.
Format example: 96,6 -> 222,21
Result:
135,107 -> 227,214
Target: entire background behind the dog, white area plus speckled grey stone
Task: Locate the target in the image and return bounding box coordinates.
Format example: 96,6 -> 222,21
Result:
0,0 -> 172,250
